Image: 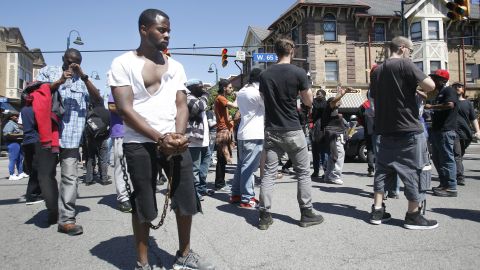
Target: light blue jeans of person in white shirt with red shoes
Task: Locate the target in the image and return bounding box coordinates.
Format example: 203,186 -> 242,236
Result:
232,140 -> 263,203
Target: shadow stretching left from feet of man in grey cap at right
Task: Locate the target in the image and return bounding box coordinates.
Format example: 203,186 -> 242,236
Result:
313,202 -> 404,227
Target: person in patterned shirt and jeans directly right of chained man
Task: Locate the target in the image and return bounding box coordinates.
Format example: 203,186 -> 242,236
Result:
186,79 -> 215,201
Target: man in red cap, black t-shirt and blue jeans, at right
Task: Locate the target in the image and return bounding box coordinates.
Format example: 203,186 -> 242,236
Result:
425,69 -> 458,197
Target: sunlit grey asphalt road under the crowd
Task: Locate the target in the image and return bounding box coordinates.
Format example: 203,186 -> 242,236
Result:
0,144 -> 480,269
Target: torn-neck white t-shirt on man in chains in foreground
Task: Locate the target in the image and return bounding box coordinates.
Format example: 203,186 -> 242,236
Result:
108,51 -> 187,143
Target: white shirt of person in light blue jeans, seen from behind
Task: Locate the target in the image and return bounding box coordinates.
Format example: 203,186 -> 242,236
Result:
237,83 -> 265,140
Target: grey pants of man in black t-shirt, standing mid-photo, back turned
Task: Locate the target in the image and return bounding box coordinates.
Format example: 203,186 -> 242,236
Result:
260,130 -> 312,212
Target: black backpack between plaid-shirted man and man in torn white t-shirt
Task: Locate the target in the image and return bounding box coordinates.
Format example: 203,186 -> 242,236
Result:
85,104 -> 110,141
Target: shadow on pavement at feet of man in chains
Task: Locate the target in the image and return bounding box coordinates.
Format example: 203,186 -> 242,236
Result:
90,235 -> 175,269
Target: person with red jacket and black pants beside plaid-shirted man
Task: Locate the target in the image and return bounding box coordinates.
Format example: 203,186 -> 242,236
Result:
21,83 -> 60,225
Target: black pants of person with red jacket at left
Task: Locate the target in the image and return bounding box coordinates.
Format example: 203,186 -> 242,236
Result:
27,143 -> 58,212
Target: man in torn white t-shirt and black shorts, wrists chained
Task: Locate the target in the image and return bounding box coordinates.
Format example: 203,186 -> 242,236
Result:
108,9 -> 215,269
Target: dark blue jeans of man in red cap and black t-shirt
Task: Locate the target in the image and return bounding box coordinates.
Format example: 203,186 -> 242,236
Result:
430,130 -> 457,190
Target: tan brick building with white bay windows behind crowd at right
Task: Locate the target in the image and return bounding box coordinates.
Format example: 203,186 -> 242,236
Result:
243,0 -> 480,100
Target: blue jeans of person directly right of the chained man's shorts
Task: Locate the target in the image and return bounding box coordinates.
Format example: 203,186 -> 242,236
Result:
188,146 -> 210,195
